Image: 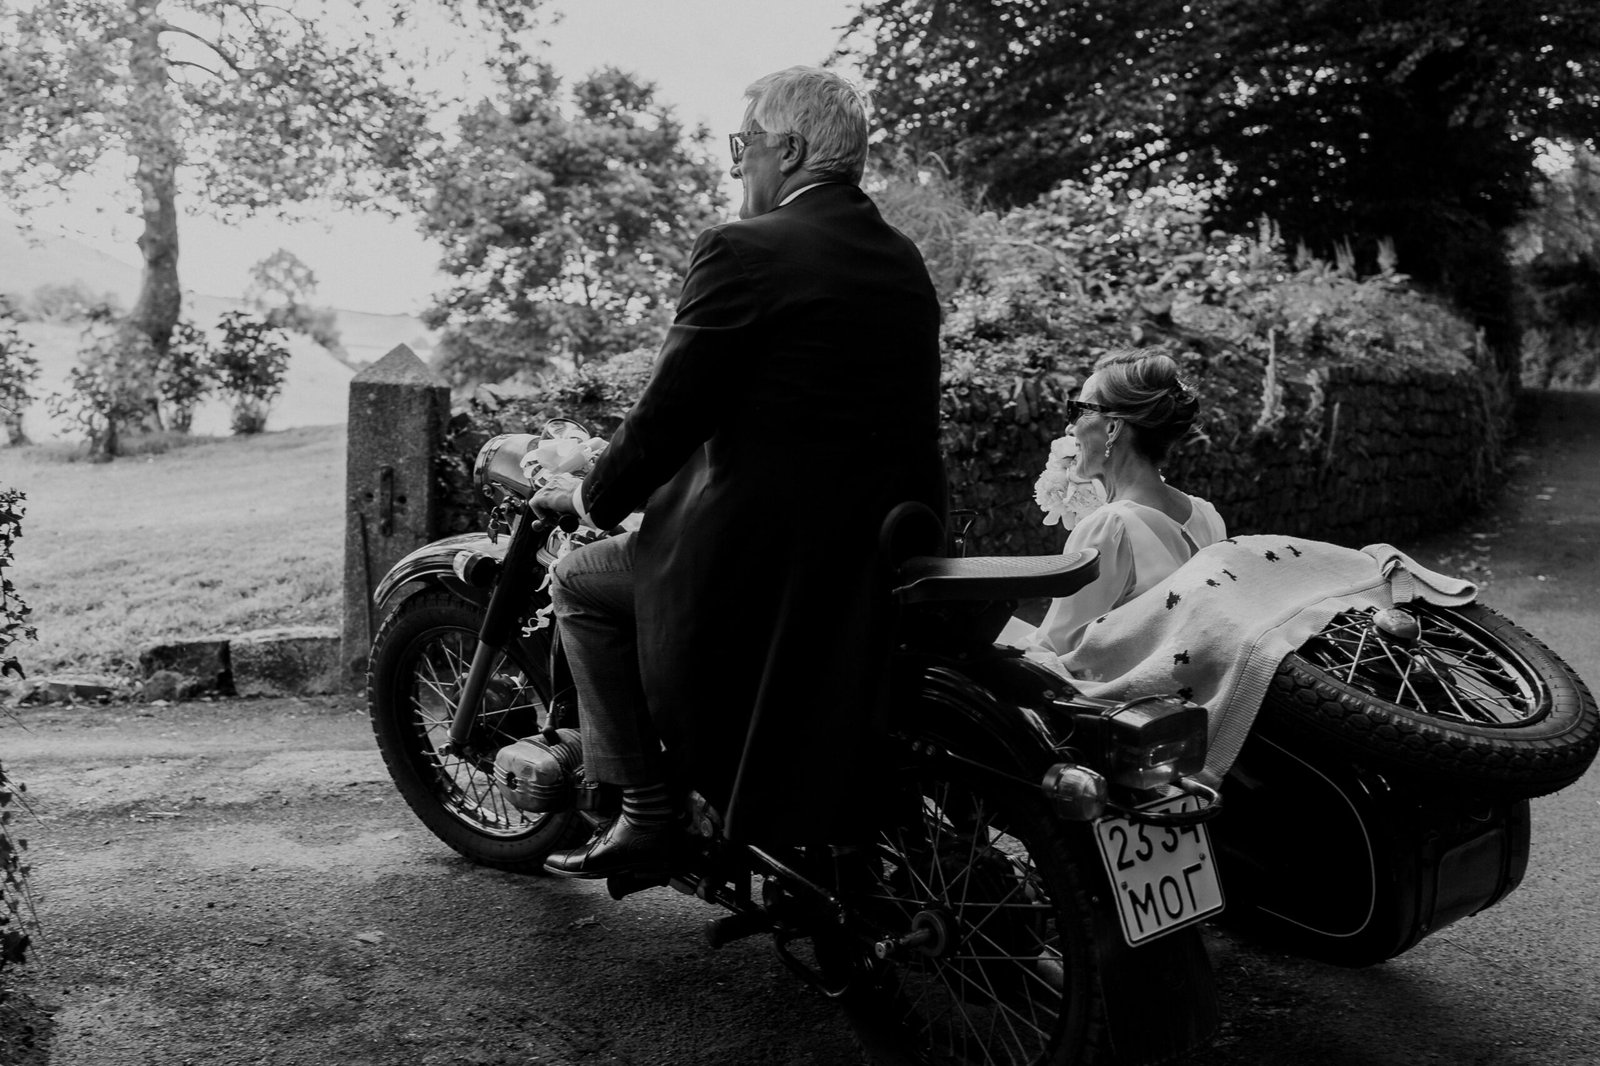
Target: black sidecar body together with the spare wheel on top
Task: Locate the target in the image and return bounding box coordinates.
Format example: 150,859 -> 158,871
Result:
1213,603 -> 1600,965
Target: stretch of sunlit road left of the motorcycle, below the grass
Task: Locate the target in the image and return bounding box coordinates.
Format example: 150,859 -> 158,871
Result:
0,699 -> 853,1066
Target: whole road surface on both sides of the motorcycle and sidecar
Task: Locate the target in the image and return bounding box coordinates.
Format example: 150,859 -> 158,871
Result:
0,394 -> 1600,1066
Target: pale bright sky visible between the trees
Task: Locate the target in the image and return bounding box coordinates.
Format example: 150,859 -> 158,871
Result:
18,0 -> 858,314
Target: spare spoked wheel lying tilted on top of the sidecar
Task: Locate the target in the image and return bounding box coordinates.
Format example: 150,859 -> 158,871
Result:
1258,603 -> 1600,799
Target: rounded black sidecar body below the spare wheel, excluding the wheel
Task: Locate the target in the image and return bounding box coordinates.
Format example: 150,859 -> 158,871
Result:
1211,722 -> 1530,967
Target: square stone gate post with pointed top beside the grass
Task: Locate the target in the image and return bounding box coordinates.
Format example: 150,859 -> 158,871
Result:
339,344 -> 450,687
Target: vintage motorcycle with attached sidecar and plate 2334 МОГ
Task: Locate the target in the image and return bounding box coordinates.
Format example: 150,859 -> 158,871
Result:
366,419 -> 1600,1063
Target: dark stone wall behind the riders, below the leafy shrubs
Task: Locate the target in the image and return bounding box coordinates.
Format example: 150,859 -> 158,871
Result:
438,356 -> 1509,555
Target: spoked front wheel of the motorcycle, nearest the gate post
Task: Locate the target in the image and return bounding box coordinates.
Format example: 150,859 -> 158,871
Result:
366,592 -> 581,872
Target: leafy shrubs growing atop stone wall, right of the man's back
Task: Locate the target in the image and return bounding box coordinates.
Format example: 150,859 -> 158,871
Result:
944,182 -> 1478,435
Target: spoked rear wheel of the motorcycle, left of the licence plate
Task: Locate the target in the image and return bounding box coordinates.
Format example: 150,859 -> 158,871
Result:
824,729 -> 1109,1066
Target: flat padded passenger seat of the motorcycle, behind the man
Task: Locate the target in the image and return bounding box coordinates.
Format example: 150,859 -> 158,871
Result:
894,549 -> 1099,603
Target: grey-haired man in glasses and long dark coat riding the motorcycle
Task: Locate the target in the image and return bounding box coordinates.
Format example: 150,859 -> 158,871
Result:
536,67 -> 944,877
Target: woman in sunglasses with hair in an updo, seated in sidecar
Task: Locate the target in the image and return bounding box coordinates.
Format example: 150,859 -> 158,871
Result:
1029,351 -> 1227,656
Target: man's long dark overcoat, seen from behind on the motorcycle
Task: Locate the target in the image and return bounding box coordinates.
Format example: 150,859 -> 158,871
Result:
582,184 -> 946,839
